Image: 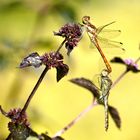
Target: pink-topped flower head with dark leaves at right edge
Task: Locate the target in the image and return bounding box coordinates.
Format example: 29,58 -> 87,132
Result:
111,57 -> 140,73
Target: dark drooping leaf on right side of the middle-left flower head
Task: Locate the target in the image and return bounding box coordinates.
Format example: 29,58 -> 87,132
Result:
56,64 -> 69,82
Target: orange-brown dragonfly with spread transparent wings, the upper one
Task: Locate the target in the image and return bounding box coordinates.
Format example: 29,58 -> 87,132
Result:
82,16 -> 124,73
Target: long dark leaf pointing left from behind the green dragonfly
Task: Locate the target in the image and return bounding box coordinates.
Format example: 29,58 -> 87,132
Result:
70,78 -> 100,98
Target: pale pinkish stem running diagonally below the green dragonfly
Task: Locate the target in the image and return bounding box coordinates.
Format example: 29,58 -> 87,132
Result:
52,100 -> 98,139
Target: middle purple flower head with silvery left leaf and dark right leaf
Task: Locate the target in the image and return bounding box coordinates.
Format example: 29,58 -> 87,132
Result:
19,52 -> 69,81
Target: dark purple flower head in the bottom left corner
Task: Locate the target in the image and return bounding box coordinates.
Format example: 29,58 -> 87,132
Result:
0,106 -> 32,140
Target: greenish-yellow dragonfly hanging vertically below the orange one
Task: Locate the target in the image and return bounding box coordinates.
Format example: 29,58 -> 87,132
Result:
98,69 -> 112,131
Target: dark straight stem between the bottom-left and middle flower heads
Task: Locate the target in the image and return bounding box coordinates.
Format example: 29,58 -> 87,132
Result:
21,66 -> 48,113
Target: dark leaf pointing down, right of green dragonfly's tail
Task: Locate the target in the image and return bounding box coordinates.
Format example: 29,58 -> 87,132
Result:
108,106 -> 121,129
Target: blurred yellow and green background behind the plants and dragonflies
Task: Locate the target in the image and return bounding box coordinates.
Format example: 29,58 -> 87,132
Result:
0,0 -> 140,140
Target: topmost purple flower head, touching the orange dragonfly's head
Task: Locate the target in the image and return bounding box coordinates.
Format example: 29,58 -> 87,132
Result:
54,23 -> 83,55
